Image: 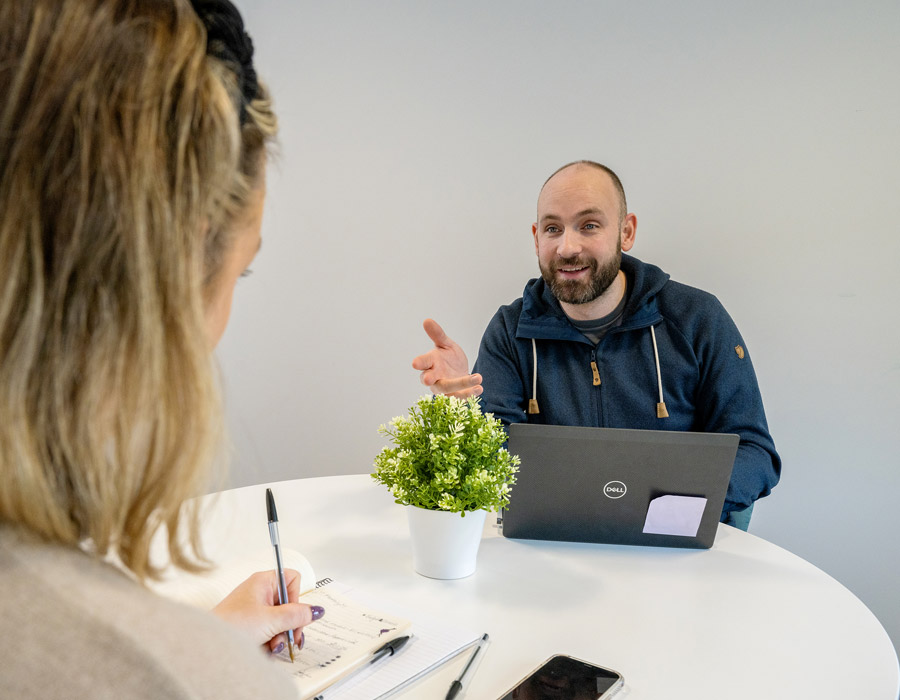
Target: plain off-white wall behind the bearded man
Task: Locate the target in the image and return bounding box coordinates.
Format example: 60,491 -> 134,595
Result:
219,0 -> 900,656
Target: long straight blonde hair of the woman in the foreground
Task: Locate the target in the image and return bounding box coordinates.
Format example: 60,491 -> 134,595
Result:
0,0 -> 275,579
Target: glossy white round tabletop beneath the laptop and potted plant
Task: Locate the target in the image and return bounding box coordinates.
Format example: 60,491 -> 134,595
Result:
192,474 -> 900,700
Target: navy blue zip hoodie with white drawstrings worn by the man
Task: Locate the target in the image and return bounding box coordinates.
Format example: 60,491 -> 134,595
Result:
473,255 -> 781,519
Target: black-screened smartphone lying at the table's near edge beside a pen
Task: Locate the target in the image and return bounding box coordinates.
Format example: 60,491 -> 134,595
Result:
499,654 -> 625,700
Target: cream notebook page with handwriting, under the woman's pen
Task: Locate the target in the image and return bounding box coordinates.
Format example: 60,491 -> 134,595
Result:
291,587 -> 409,678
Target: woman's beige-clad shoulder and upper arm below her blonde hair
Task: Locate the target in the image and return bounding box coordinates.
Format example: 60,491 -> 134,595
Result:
0,527 -> 296,700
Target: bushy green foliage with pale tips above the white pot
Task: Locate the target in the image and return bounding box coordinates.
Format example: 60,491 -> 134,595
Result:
372,396 -> 519,516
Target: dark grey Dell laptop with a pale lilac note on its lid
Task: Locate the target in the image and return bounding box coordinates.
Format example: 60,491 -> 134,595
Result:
501,423 -> 740,549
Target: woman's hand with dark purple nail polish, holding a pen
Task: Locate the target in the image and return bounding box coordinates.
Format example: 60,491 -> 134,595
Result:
213,569 -> 325,654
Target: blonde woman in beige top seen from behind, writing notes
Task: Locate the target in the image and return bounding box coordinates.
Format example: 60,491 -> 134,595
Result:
0,0 -> 321,700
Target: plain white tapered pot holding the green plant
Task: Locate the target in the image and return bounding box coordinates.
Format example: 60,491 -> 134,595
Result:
406,506 -> 487,579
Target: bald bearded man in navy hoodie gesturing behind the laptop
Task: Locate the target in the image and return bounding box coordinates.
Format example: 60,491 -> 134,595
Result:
413,161 -> 781,529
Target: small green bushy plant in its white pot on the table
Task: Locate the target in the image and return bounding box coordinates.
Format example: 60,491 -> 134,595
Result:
372,395 -> 519,579
